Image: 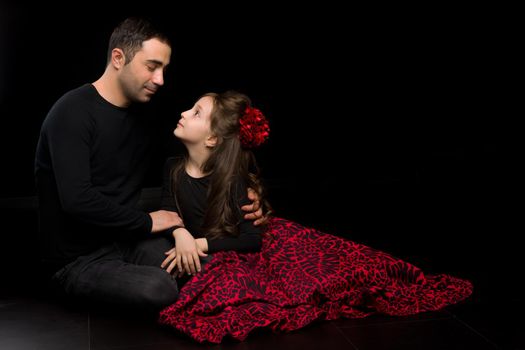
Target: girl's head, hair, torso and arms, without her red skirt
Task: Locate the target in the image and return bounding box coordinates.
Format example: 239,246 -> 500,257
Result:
162,92 -> 269,275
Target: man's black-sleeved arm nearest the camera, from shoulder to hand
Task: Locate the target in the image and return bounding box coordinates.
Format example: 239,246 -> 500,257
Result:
45,106 -> 174,232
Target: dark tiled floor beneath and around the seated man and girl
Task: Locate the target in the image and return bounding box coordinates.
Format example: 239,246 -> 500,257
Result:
0,204 -> 525,350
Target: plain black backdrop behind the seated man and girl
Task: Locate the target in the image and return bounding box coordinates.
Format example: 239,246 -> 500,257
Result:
0,2 -> 522,292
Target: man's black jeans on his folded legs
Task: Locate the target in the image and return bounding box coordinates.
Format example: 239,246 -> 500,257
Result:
53,236 -> 186,311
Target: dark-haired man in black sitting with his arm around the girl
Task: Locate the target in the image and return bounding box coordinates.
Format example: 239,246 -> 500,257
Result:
35,18 -> 262,310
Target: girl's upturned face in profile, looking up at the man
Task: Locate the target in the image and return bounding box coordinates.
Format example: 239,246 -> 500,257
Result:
173,96 -> 213,146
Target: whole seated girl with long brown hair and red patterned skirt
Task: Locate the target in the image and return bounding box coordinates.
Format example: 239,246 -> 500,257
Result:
156,92 -> 472,343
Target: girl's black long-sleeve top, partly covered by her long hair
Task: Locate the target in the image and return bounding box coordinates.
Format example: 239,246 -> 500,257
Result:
161,158 -> 262,253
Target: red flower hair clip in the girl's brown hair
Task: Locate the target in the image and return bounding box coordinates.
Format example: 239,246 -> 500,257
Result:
239,107 -> 270,148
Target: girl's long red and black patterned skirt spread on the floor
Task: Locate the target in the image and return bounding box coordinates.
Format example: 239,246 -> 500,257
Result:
159,218 -> 472,343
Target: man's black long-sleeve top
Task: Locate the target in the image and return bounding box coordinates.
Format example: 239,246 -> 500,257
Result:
35,84 -> 152,261
